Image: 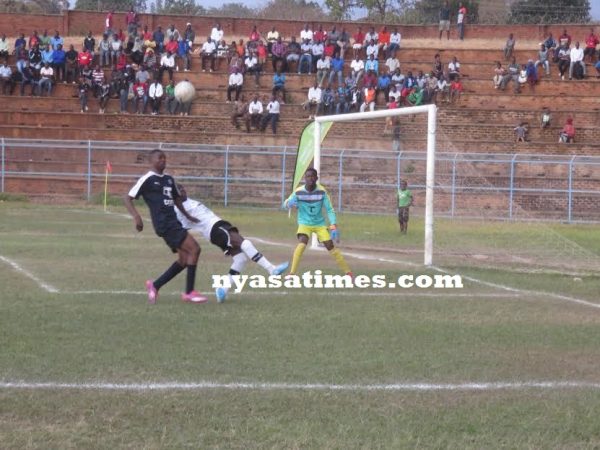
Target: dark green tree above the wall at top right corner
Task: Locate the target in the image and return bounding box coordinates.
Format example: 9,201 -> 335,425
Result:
510,0 -> 590,24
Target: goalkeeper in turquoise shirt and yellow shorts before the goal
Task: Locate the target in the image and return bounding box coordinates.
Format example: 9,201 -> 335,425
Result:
283,168 -> 353,277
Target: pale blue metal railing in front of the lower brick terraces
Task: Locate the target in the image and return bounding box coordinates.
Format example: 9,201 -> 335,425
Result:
0,138 -> 600,222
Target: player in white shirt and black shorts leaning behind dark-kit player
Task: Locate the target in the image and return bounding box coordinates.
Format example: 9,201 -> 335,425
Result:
176,184 -> 289,303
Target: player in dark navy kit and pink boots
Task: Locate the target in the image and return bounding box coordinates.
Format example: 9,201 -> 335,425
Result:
125,149 -> 208,304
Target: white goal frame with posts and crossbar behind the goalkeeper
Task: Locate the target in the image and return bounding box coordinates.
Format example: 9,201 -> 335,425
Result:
312,105 -> 437,266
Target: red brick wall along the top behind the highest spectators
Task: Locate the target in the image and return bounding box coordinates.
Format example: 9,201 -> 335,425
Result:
0,10 -> 589,40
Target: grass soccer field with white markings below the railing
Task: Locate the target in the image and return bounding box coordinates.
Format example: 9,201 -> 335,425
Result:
0,202 -> 600,449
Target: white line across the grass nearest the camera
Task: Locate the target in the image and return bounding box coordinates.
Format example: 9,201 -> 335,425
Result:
0,381 -> 600,392
